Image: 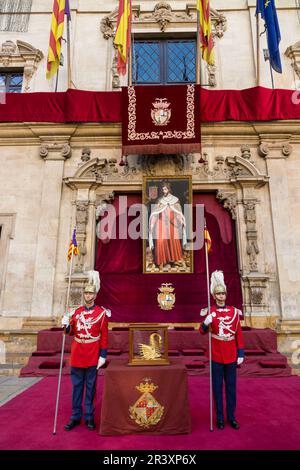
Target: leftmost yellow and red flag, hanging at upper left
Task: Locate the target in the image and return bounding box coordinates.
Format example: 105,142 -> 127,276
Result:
46,0 -> 66,79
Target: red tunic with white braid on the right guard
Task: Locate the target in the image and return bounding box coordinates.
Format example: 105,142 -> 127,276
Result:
199,305 -> 244,364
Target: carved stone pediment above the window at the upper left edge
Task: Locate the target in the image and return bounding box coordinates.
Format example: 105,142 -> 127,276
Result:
0,40 -> 44,93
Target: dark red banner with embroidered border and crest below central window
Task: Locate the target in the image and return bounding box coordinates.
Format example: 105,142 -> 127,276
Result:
122,84 -> 201,155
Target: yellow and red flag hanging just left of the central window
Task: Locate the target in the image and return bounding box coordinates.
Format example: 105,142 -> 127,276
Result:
114,0 -> 131,75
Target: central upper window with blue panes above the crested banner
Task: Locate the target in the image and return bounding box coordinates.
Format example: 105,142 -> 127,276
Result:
132,39 -> 196,85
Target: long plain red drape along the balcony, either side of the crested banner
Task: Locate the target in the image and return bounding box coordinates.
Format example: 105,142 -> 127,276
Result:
0,87 -> 300,122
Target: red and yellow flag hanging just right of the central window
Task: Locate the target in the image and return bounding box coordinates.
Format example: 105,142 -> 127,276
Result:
197,0 -> 215,65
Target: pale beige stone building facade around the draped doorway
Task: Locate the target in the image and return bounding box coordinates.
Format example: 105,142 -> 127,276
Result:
0,0 -> 300,370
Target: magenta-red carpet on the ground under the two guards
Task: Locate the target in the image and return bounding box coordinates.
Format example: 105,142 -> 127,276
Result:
0,376 -> 300,450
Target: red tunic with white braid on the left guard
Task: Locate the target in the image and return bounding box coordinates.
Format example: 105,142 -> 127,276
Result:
69,305 -> 108,368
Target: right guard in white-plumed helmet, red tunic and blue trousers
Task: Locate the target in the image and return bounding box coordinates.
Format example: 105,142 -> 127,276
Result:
200,271 -> 244,429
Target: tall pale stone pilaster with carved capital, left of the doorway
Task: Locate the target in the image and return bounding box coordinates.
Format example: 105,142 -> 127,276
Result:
23,142 -> 71,329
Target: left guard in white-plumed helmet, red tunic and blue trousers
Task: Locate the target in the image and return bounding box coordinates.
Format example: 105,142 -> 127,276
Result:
62,271 -> 111,431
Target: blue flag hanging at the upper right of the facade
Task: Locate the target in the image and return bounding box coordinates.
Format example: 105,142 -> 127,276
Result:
256,0 -> 282,73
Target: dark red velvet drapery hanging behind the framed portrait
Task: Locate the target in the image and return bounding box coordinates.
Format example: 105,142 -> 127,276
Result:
95,194 -> 242,323
